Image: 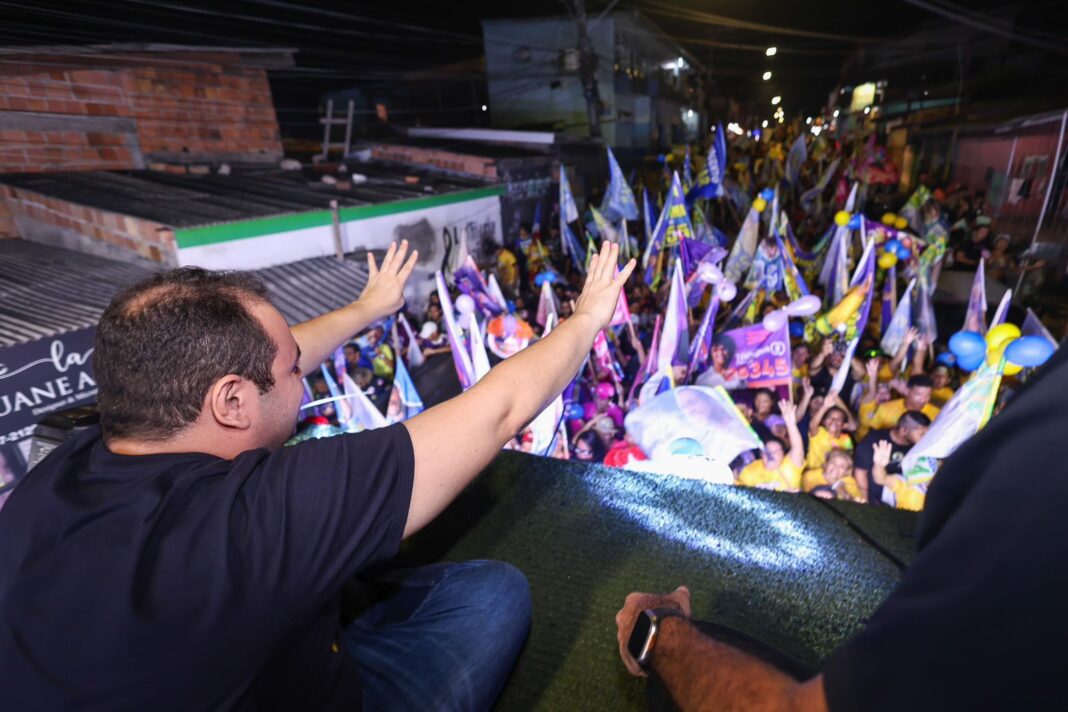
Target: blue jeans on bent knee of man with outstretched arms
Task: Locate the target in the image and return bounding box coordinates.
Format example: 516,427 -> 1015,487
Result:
342,560 -> 531,710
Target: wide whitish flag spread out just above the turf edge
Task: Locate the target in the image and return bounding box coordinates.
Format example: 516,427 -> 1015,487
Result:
624,385 -> 764,463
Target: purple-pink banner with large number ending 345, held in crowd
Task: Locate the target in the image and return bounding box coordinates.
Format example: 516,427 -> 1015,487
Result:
713,325 -> 792,393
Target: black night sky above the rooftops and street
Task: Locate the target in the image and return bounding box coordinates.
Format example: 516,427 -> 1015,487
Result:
0,0 -> 1068,136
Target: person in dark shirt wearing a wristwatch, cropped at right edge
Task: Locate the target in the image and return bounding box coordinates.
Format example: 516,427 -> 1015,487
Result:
616,348 -> 1068,712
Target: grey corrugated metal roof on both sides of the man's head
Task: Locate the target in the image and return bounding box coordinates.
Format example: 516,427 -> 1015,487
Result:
0,240 -> 367,347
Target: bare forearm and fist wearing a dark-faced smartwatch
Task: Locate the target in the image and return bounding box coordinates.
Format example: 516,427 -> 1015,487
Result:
615,586 -> 827,712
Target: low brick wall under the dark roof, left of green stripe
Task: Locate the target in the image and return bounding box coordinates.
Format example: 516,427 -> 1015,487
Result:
0,186 -> 177,265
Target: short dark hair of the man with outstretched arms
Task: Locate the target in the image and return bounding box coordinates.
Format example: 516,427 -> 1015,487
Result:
93,267 -> 278,441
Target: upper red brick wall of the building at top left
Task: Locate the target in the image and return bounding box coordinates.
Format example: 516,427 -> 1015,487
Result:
0,57 -> 282,173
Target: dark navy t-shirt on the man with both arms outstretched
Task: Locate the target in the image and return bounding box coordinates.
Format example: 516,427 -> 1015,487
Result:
0,424 -> 414,711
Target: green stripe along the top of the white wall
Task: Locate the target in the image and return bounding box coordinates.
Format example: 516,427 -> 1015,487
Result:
174,186 -> 504,249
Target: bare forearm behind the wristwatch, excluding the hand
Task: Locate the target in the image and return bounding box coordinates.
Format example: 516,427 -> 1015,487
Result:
653,618 -> 826,712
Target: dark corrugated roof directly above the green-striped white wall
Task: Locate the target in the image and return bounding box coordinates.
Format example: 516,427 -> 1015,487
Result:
0,164 -> 486,227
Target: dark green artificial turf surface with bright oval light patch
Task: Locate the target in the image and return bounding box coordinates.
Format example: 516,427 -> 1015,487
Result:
402,453 -> 916,710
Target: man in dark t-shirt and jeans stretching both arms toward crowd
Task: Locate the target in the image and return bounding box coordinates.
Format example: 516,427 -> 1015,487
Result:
0,242 -> 633,711
